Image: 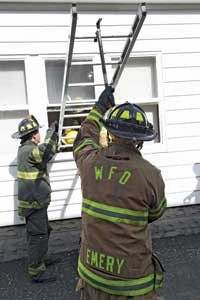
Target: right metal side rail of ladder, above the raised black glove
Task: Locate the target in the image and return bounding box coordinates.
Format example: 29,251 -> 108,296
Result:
111,3 -> 146,88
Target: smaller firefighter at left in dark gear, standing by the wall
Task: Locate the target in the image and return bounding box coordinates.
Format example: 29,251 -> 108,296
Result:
12,116 -> 58,282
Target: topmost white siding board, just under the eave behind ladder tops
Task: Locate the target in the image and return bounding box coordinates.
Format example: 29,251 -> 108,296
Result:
0,11 -> 200,26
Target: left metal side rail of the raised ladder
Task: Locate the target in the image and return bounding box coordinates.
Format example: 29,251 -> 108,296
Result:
58,5 -> 77,148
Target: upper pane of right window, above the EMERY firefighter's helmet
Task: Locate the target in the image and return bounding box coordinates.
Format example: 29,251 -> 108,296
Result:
113,57 -> 157,103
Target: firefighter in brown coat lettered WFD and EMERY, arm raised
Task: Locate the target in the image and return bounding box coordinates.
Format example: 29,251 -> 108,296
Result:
74,86 -> 166,300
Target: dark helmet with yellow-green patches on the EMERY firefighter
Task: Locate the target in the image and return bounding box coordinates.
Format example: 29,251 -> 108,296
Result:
101,102 -> 156,141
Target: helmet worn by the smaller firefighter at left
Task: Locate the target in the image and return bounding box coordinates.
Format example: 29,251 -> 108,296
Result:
12,116 -> 41,139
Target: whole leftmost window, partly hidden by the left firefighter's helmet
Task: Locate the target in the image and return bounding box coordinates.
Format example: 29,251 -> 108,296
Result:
0,61 -> 28,154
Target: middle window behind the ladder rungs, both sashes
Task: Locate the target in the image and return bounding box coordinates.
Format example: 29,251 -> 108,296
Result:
45,59 -> 95,151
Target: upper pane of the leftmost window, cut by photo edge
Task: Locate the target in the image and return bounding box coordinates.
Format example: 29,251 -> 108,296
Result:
0,61 -> 27,105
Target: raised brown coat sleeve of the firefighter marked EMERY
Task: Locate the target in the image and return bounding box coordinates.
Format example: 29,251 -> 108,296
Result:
73,107 -> 103,167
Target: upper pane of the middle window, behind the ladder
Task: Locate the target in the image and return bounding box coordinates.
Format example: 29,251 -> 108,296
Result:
45,60 -> 95,104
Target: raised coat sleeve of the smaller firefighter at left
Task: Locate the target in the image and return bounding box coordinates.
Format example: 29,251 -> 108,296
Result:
31,128 -> 58,166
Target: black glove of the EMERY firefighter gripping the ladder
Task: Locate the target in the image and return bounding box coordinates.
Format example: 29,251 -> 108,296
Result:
95,85 -> 115,113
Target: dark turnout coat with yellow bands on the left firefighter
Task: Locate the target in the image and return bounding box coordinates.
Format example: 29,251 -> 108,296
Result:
17,128 -> 58,218
